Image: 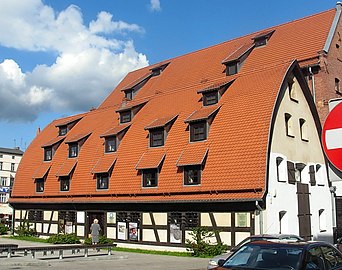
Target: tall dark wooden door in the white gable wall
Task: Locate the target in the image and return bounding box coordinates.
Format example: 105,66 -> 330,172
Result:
297,183 -> 312,240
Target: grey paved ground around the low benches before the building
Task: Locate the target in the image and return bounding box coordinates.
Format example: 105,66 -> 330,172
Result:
0,238 -> 208,270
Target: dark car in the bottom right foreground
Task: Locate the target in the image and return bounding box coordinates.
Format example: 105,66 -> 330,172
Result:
216,240 -> 342,270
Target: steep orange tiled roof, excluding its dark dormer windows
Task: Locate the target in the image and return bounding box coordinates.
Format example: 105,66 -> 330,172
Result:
11,7 -> 335,203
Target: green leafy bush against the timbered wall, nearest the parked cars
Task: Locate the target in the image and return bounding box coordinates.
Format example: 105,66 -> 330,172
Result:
186,227 -> 228,257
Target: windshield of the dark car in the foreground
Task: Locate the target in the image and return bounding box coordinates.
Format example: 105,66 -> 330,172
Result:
223,244 -> 302,270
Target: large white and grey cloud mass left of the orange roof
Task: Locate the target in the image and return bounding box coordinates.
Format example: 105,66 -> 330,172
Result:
0,0 -> 148,121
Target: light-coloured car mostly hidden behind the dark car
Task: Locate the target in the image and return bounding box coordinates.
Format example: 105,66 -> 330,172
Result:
207,234 -> 304,270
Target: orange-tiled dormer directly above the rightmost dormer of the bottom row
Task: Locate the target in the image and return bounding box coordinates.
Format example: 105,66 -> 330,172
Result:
184,106 -> 220,142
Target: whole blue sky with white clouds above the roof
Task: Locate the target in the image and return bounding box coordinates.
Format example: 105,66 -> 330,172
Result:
0,0 -> 336,150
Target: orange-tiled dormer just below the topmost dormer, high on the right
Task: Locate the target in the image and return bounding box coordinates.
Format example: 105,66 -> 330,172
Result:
222,43 -> 255,76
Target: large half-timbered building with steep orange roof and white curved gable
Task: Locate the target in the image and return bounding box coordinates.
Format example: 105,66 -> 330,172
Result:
10,4 -> 342,247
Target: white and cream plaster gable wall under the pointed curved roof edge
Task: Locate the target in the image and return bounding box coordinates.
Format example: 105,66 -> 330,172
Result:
263,76 -> 333,241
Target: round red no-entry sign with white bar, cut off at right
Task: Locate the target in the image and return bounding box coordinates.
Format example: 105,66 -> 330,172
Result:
322,102 -> 342,171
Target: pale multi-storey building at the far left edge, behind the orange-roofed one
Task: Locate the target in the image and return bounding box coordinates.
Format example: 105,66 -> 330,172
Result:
0,147 -> 24,225
